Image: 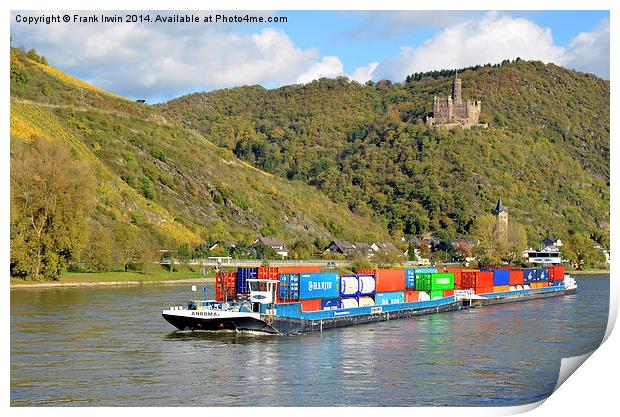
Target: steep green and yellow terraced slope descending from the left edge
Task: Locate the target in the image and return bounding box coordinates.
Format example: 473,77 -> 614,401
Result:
11,48 -> 390,276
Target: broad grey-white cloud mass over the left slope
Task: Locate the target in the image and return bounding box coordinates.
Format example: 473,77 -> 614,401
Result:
11,12 -> 324,99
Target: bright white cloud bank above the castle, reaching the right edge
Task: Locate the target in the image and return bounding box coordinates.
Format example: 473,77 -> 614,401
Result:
373,12 -> 609,81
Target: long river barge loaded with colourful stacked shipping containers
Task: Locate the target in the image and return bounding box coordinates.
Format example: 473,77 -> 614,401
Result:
162,266 -> 577,335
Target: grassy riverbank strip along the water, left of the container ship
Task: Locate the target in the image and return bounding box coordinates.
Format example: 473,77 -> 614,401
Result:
11,271 -> 215,289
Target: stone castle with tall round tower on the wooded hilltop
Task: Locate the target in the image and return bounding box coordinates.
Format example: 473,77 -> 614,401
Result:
426,75 -> 487,129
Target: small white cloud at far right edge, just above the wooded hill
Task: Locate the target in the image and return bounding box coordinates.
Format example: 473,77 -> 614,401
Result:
565,19 -> 609,79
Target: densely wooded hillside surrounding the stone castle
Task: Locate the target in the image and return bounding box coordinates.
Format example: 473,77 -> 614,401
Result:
158,60 -> 609,243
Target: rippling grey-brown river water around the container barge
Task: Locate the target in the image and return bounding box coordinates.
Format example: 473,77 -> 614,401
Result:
11,275 -> 609,406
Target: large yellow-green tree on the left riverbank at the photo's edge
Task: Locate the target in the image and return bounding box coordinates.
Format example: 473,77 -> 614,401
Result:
11,138 -> 95,280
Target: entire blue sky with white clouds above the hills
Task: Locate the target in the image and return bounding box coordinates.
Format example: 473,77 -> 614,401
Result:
11,10 -> 610,103
